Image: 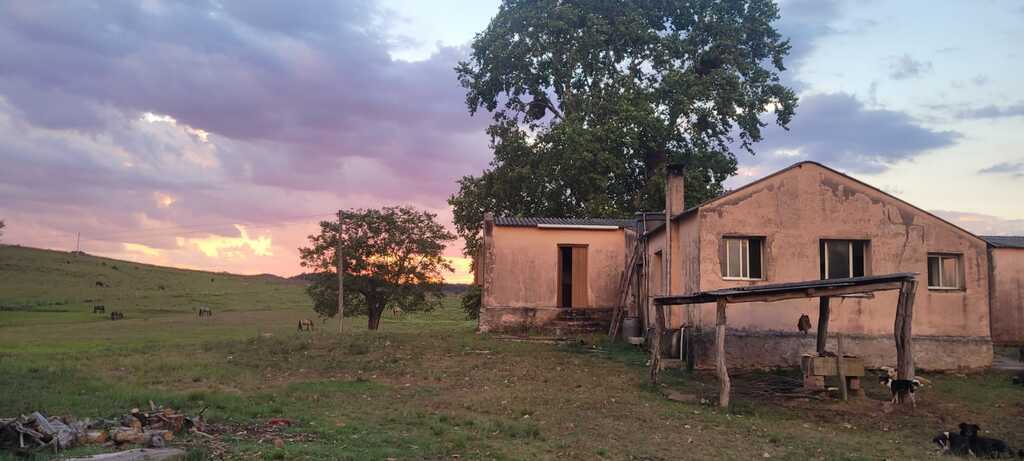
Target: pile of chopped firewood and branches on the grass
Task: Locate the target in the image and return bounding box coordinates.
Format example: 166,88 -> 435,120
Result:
0,402 -> 203,454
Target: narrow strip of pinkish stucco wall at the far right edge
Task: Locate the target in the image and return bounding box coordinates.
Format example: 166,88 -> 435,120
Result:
990,248 -> 1024,345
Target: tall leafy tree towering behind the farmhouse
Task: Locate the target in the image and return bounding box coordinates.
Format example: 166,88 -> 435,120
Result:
449,0 -> 797,254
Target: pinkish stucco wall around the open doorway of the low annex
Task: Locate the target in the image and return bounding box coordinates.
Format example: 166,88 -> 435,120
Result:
482,226 -> 626,308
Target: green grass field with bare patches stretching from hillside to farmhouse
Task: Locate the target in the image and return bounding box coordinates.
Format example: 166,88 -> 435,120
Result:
0,246 -> 1024,460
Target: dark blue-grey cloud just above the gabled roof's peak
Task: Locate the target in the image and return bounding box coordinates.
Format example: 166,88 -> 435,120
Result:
753,93 -> 961,173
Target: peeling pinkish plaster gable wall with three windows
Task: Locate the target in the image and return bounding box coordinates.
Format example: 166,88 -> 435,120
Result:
651,163 -> 991,368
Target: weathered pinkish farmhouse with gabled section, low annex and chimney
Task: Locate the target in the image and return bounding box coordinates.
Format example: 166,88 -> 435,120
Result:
477,162 -> 1024,369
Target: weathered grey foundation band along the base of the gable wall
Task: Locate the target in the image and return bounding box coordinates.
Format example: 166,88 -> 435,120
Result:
679,329 -> 992,371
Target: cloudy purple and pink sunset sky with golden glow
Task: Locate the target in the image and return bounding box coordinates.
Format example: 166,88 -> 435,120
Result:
0,0 -> 1024,282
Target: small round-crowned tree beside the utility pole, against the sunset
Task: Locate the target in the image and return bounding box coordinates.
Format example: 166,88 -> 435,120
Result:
299,207 -> 455,330
